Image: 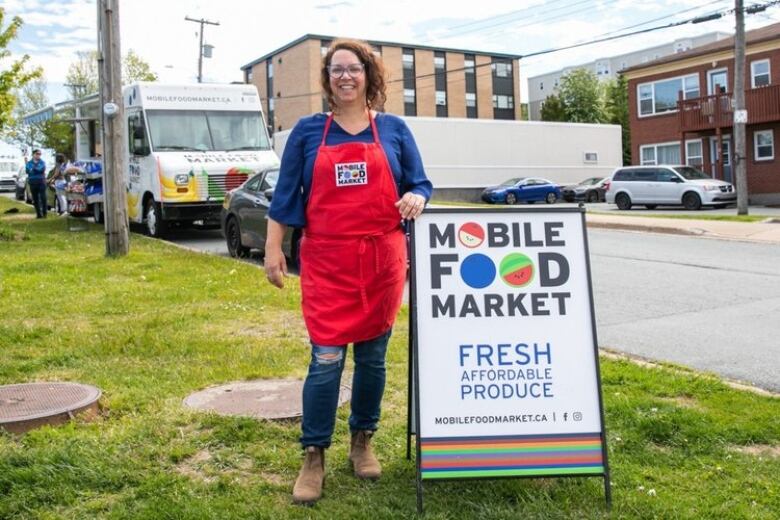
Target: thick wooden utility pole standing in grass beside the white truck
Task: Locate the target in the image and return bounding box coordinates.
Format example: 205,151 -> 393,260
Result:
97,0 -> 130,256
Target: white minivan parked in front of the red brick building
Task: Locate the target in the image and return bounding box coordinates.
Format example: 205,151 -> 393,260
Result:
606,165 -> 737,210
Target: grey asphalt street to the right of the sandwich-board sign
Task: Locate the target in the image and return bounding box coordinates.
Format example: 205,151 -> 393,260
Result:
589,230 -> 780,391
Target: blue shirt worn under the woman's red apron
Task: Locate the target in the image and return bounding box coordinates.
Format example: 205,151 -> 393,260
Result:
268,113 -> 433,227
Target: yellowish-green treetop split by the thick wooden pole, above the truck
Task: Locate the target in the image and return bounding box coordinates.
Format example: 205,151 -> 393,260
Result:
65,49 -> 157,99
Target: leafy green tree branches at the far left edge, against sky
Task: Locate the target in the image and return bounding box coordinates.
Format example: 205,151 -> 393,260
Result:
0,7 -> 41,131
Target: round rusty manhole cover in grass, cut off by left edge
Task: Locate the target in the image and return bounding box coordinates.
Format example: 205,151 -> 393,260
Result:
0,383 -> 101,433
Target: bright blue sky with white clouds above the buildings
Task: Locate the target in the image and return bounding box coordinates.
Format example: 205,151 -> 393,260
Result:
0,0 -> 780,103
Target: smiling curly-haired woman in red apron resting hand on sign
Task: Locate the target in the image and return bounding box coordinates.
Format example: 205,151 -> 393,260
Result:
265,40 -> 432,504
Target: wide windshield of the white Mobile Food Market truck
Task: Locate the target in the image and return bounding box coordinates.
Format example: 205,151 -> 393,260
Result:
146,110 -> 271,152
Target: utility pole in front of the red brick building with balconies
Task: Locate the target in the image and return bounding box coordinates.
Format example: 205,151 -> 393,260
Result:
733,0 -> 748,215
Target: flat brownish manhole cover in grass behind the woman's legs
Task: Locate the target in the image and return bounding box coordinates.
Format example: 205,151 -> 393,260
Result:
184,379 -> 352,419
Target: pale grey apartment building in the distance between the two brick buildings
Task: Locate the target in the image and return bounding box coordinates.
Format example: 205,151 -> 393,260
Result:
528,32 -> 730,121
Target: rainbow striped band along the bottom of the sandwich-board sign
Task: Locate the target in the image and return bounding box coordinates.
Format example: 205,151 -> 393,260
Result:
420,433 -> 604,479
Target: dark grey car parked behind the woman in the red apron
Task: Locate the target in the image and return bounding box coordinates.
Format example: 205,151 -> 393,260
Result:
220,170 -> 301,265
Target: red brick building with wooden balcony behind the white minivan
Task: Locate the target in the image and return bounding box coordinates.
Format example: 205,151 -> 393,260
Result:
624,24 -> 780,203
